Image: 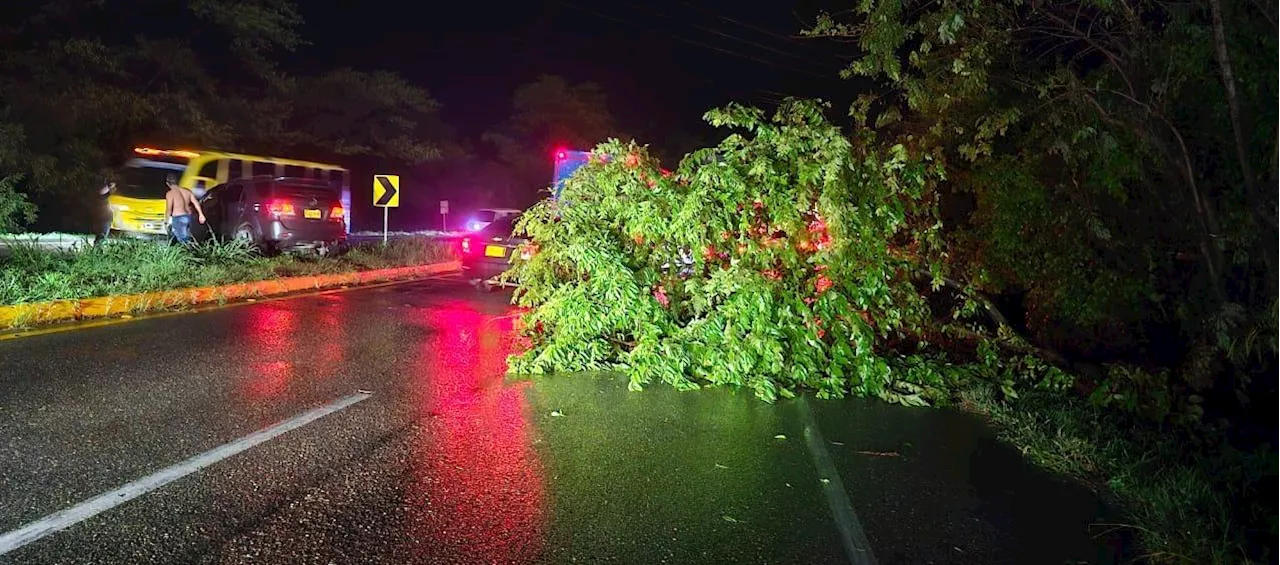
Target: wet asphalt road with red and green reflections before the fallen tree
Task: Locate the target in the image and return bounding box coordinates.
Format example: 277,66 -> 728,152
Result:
0,281 -> 1126,564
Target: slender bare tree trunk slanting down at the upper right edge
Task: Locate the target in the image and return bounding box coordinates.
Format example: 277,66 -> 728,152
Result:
1208,0 -> 1280,293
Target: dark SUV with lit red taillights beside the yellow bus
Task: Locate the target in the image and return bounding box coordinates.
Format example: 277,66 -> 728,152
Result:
201,177 -> 347,254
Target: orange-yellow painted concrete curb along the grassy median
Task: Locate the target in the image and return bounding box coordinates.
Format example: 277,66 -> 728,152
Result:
0,261 -> 462,331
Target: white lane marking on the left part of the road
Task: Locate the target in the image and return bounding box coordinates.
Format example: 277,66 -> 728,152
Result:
0,392 -> 372,555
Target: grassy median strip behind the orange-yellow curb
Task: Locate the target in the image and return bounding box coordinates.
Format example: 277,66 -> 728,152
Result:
0,238 -> 453,305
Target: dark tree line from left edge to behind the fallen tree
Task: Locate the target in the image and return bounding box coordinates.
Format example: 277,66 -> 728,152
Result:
0,0 -> 629,232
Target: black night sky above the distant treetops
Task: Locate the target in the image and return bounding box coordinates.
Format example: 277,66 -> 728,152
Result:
294,0 -> 850,143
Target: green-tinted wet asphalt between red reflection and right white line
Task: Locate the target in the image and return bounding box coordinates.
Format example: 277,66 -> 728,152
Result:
529,375 -> 847,564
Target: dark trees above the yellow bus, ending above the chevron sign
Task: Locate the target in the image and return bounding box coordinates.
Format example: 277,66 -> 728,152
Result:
0,0 -> 444,222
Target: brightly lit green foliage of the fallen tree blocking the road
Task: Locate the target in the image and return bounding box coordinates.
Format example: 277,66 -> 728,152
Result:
511,101 -> 941,402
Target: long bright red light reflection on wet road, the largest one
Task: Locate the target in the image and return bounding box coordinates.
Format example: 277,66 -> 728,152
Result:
410,301 -> 545,564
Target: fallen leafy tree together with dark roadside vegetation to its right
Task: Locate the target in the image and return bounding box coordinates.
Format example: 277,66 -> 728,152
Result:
511,0 -> 1280,564
